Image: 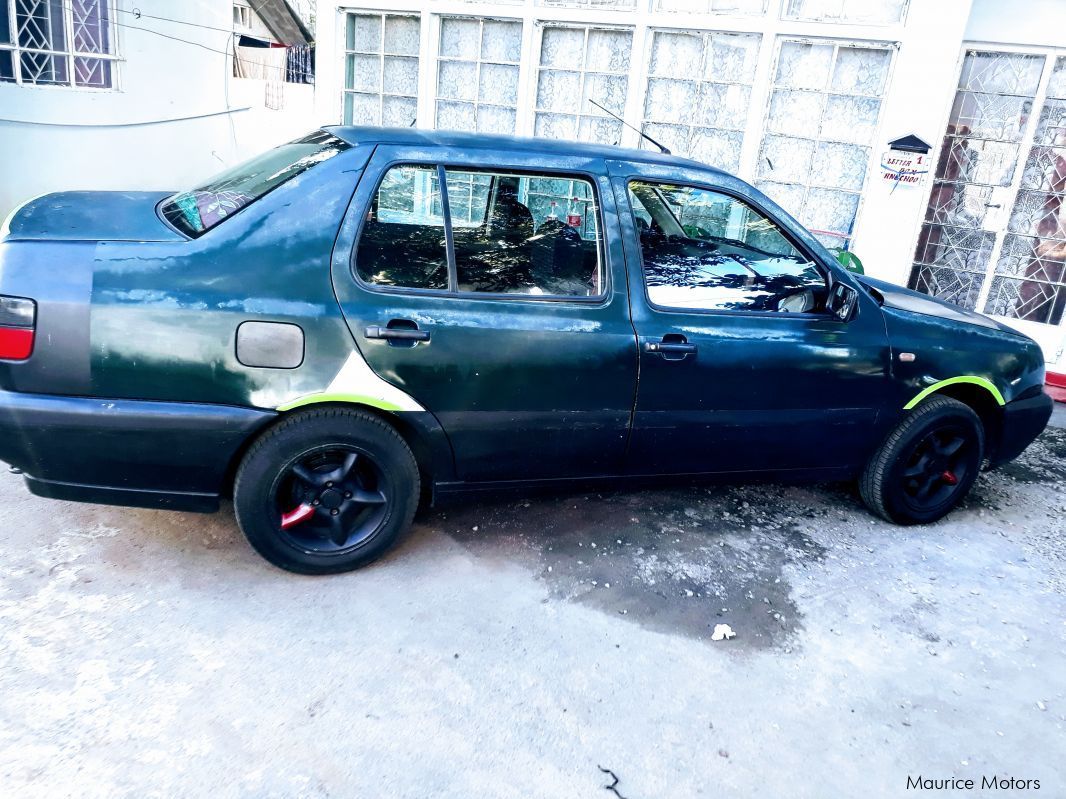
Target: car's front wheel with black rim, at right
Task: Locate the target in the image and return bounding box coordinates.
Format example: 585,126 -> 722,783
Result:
859,396 -> 985,524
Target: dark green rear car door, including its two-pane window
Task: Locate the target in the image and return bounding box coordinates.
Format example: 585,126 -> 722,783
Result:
334,146 -> 636,482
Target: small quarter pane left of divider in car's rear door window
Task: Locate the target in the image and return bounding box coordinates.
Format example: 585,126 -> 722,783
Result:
355,165 -> 448,291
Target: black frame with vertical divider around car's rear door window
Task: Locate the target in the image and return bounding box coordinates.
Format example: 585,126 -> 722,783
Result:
349,158 -> 613,306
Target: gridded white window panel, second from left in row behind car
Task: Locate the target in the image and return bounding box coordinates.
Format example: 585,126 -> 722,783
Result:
436,17 -> 522,133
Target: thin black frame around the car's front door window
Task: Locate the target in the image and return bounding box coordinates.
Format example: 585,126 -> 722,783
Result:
626,175 -> 844,324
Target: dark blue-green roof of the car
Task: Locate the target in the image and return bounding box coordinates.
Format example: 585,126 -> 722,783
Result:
324,126 -> 729,175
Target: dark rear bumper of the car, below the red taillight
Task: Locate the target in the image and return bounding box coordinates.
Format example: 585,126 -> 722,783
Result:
0,391 -> 276,511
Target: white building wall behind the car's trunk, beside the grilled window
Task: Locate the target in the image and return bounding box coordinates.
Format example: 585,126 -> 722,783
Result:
0,0 -> 313,218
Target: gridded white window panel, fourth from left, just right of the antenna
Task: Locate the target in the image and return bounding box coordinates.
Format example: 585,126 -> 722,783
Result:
641,31 -> 761,172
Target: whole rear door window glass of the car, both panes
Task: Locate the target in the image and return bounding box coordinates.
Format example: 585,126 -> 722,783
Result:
355,165 -> 604,297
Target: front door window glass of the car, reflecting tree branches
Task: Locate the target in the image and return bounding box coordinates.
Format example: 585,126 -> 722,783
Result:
629,181 -> 828,313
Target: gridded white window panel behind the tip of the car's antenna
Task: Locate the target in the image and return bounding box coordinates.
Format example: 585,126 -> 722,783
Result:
534,25 -> 633,144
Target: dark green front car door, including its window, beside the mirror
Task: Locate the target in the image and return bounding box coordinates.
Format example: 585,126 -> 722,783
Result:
610,162 -> 889,473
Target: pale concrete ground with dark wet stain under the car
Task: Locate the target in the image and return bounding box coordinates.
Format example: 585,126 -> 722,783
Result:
0,411 -> 1066,799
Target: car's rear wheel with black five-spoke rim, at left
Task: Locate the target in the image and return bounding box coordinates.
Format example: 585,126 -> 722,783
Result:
233,408 -> 419,574
